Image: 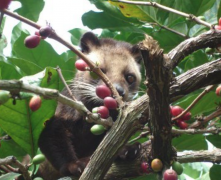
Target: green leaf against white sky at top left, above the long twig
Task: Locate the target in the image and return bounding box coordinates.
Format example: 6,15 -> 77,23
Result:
15,0 -> 45,22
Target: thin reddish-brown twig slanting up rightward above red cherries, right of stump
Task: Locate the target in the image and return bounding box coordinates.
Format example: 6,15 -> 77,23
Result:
172,85 -> 214,121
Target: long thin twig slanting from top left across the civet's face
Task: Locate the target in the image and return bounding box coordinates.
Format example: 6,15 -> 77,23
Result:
1,9 -> 123,107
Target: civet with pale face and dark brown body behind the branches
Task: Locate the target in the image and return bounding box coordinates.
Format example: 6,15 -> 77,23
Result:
39,33 -> 141,180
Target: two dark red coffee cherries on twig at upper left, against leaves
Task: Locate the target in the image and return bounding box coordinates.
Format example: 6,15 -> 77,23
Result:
24,25 -> 53,49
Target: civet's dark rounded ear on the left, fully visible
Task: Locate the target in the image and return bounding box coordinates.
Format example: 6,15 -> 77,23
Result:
80,32 -> 100,53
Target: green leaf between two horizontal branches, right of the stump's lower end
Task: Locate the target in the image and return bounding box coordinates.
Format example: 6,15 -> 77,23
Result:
172,134 -> 207,151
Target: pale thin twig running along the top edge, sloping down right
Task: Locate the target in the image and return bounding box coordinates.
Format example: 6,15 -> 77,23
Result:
110,0 -> 213,28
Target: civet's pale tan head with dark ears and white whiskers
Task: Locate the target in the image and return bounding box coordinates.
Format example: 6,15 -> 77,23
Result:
73,32 -> 141,106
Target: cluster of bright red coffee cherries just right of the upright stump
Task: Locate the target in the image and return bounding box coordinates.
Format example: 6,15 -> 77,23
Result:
170,106 -> 191,129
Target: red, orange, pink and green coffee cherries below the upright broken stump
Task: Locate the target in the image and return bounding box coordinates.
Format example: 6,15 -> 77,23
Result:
141,158 -> 183,180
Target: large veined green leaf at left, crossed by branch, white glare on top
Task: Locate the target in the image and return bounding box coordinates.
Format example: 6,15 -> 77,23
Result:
0,68 -> 59,157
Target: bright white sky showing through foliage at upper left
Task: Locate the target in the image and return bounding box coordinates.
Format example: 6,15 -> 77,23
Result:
3,0 -> 99,55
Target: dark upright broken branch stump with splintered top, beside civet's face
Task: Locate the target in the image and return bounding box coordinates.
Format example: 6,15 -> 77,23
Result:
140,36 -> 173,167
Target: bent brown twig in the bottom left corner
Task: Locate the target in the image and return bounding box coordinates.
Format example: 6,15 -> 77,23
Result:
0,156 -> 31,180
